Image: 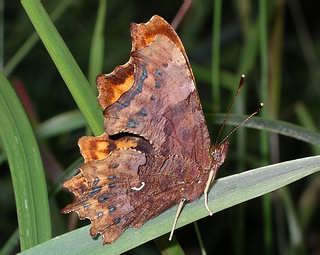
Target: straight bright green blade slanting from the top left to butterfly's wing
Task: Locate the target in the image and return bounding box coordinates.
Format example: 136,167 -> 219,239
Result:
21,0 -> 104,135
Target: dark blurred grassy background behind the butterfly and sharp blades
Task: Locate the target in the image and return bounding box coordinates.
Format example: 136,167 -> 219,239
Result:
0,0 -> 320,255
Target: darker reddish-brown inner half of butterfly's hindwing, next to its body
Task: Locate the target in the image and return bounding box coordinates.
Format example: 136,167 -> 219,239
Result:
120,155 -> 206,227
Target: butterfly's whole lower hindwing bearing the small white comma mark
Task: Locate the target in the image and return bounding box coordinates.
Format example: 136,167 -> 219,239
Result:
61,149 -> 203,243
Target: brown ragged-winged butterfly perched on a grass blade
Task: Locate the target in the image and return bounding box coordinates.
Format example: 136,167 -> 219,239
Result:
61,15 -> 229,243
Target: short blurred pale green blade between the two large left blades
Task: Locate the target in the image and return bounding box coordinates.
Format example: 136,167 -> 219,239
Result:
36,110 -> 86,139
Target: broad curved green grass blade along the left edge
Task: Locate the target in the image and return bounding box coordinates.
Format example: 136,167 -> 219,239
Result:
0,73 -> 51,250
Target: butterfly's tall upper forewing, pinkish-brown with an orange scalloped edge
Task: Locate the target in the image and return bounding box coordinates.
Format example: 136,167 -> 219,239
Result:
99,16 -> 210,166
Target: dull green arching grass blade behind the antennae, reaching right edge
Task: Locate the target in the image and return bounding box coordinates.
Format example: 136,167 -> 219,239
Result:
206,114 -> 320,145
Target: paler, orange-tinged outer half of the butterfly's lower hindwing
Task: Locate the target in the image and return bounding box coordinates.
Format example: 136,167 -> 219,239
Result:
61,149 -> 146,243
